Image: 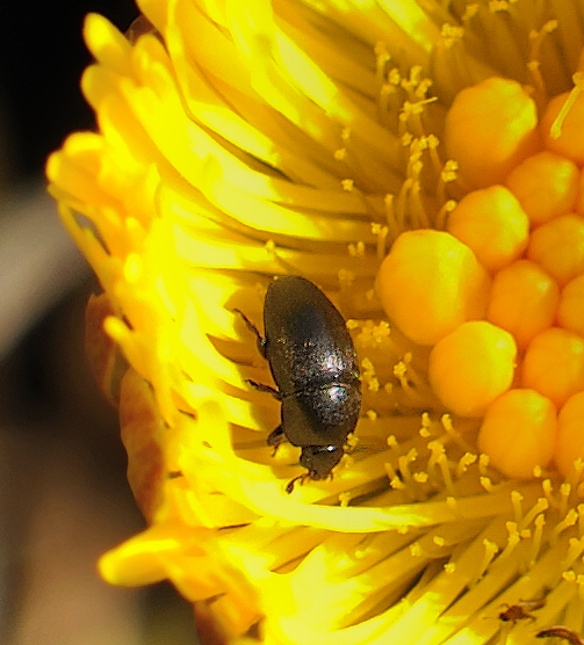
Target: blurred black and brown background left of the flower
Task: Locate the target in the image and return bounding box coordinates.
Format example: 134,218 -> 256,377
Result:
0,0 -> 195,645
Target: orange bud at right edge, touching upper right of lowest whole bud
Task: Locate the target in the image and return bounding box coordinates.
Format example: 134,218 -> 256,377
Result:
521,327 -> 584,408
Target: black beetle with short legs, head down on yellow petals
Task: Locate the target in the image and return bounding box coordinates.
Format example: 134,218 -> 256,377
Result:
236,276 -> 361,493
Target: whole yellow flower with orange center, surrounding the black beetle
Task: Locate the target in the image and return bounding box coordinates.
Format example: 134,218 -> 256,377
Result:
47,0 -> 584,645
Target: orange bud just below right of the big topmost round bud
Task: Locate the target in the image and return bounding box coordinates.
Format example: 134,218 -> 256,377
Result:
506,150 -> 580,225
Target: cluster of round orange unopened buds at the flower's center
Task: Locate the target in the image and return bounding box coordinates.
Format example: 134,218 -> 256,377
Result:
376,75 -> 584,479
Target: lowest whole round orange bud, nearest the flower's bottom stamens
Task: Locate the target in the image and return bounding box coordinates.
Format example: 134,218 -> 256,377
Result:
478,389 -> 556,479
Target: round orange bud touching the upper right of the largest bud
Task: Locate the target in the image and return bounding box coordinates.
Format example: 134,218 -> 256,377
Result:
447,186 -> 529,272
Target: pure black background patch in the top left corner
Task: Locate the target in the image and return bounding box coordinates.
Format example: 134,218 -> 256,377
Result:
0,0 -> 138,182
